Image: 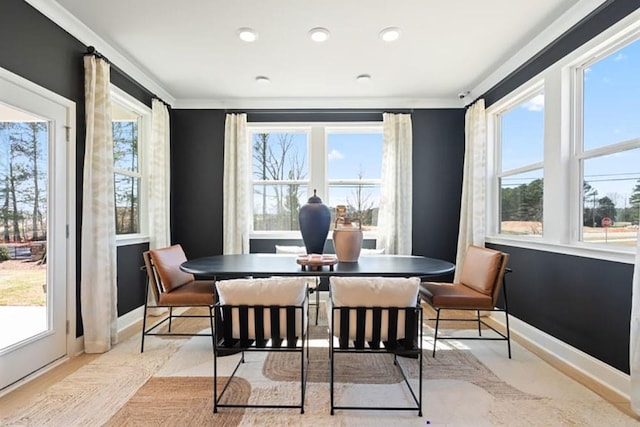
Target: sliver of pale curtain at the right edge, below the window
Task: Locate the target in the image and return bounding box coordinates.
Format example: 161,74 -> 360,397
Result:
629,244 -> 640,415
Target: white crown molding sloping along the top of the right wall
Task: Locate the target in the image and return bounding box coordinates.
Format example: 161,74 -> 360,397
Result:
466,0 -> 607,102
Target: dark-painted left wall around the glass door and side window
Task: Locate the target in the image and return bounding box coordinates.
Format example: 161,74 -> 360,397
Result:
0,0 -> 152,336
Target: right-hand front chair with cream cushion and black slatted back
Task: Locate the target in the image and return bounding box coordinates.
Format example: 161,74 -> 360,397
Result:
327,277 -> 422,416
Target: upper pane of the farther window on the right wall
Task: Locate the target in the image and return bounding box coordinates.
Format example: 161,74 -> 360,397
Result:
500,91 -> 544,171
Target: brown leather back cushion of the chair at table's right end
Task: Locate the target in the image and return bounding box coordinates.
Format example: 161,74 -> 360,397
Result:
460,245 -> 509,305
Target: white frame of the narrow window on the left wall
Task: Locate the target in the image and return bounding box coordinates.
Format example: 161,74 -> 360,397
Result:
110,84 -> 151,246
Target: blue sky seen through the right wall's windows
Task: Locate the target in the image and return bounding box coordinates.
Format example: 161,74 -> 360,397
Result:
502,36 -> 640,207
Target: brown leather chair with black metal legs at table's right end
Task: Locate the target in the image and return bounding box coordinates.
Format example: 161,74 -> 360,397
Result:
420,245 -> 511,359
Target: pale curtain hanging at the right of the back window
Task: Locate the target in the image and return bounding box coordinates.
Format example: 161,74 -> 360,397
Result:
376,113 -> 413,255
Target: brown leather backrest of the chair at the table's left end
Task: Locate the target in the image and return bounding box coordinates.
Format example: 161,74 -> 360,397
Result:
143,245 -> 194,301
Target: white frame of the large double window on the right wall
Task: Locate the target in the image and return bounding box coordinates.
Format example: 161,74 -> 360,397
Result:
485,10 -> 640,264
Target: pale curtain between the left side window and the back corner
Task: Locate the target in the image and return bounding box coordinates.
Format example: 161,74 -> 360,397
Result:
147,99 -> 171,249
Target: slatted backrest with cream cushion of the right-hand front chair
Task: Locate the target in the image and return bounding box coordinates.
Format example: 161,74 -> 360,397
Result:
327,277 -> 420,341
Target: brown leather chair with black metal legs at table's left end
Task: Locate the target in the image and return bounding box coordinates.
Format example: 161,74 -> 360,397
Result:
140,245 -> 215,353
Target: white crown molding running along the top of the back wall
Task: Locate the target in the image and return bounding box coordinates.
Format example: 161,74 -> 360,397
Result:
173,97 -> 464,110
